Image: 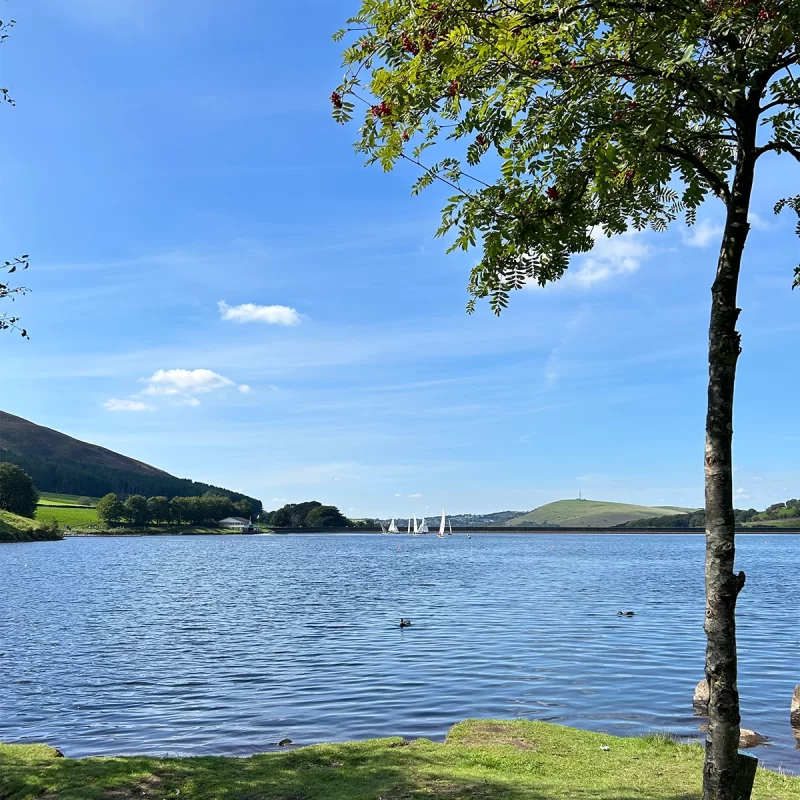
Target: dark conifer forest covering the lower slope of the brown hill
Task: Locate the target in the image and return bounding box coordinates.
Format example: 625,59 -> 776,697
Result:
0,448 -> 261,514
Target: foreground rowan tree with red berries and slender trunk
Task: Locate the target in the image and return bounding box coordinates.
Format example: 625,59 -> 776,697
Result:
331,0 -> 800,800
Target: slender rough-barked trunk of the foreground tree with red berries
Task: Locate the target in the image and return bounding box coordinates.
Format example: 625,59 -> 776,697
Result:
703,124 -> 755,800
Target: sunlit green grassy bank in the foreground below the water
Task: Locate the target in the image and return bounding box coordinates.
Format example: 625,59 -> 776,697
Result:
0,720 -> 800,800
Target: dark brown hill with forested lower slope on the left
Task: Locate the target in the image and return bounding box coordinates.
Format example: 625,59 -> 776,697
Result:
0,411 -> 261,509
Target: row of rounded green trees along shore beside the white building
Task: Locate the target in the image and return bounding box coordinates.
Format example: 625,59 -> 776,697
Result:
97,492 -> 256,527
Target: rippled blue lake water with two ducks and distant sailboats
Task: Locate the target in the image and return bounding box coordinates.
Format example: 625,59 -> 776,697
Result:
0,534 -> 800,772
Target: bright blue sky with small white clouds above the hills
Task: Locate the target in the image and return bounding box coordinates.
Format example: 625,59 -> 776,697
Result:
0,0 -> 800,516
